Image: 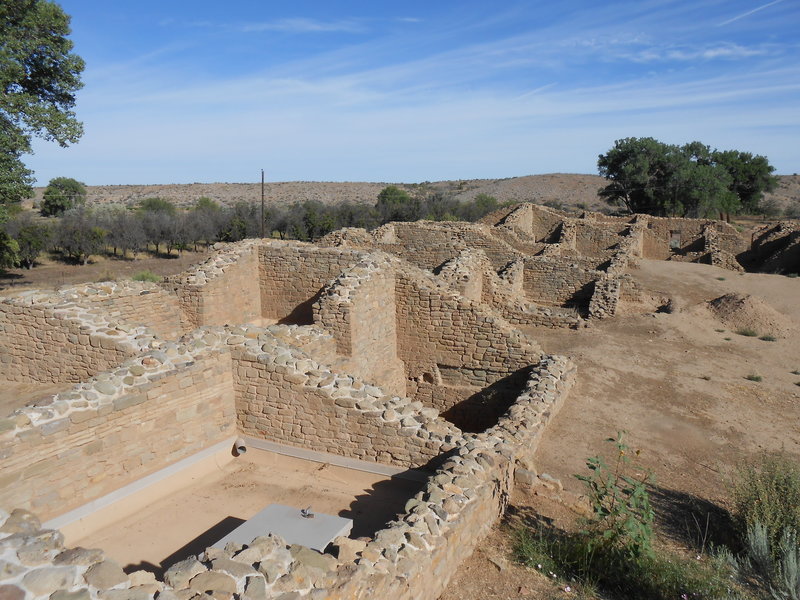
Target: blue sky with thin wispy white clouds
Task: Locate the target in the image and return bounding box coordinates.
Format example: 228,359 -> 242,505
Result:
27,0 -> 800,185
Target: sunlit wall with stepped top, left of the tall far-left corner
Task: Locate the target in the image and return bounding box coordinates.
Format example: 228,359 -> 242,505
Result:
160,240 -> 262,328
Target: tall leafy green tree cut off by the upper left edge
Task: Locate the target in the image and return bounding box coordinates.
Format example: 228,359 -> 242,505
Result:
0,0 -> 84,203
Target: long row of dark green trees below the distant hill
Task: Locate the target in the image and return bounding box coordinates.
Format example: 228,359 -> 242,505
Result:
0,185 -> 499,269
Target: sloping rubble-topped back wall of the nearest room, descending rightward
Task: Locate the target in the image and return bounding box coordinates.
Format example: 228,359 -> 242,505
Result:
220,328 -> 461,467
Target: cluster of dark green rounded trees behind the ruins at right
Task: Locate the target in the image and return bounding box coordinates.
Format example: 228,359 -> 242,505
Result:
597,137 -> 777,217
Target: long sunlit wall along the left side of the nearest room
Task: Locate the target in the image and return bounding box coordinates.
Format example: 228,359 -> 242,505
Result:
0,344 -> 236,518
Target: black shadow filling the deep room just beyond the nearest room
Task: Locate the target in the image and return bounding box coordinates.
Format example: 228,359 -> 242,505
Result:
442,367 -> 533,433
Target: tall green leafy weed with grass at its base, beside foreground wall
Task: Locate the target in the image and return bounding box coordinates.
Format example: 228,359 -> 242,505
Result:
514,434 -> 744,600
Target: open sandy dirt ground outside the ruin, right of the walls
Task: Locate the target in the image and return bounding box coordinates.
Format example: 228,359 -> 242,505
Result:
442,260 -> 800,600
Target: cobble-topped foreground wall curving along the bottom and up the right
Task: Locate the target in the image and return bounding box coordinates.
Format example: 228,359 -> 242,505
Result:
0,357 -> 575,600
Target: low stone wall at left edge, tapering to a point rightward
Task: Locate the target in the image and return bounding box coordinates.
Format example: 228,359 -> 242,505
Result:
0,290 -> 155,383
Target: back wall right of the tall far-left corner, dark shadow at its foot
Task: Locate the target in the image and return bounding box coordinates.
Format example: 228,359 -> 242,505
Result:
260,241 -> 364,324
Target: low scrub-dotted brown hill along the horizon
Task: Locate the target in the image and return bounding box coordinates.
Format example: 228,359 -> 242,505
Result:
29,173 -> 800,210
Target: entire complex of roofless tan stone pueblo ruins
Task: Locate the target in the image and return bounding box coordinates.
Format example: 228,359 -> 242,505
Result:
0,204 -> 800,600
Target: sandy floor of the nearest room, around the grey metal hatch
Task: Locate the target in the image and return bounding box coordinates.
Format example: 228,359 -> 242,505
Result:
75,450 -> 422,574
